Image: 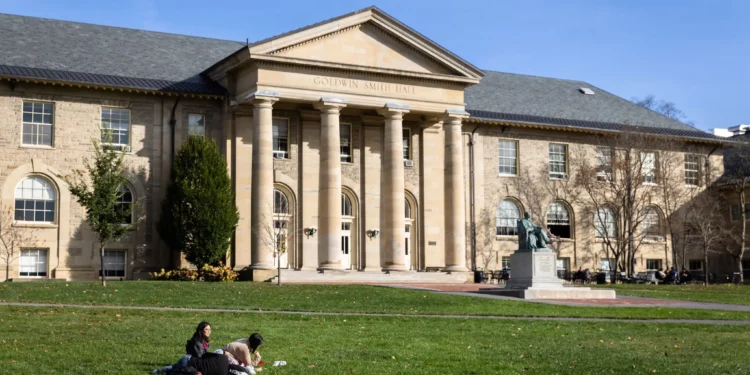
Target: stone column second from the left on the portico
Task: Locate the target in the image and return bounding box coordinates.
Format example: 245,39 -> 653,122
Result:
315,98 -> 346,271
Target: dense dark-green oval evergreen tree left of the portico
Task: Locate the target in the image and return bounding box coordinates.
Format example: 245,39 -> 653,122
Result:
158,135 -> 239,268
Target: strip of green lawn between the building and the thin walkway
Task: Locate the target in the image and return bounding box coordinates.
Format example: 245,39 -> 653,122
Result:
0,281 -> 750,320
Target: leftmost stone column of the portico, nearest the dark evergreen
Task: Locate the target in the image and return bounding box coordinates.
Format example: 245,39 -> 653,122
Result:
251,91 -> 279,269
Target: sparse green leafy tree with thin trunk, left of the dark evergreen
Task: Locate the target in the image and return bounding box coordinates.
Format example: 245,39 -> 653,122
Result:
59,135 -> 133,286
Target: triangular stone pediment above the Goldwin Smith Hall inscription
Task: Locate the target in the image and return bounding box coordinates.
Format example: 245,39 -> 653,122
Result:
249,7 -> 483,82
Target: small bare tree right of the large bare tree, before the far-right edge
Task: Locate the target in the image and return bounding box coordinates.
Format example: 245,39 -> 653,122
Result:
685,190 -> 731,285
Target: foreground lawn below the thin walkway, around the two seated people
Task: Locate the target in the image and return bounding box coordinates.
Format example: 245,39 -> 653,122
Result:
0,306 -> 750,375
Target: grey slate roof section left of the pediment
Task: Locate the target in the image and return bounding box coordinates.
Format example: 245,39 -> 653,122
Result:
0,14 -> 245,94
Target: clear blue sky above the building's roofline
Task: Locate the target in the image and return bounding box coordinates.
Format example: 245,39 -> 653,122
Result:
0,0 -> 750,130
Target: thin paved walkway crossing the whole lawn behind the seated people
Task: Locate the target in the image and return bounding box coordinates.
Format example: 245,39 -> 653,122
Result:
0,302 -> 750,326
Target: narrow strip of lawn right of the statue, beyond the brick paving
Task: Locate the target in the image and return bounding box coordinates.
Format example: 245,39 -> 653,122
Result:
605,284 -> 750,305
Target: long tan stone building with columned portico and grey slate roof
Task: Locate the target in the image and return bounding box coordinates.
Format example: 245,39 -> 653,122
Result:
0,7 -> 722,281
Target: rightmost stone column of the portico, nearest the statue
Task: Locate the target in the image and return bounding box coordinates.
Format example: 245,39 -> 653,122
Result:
443,110 -> 469,272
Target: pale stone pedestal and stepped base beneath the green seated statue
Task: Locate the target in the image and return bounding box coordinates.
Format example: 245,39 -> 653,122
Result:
480,250 -> 615,299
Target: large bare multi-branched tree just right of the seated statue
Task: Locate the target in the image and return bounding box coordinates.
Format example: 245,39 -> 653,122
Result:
572,129 -> 660,275
